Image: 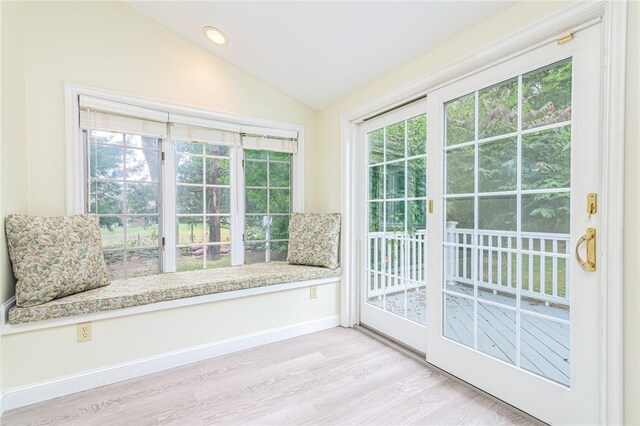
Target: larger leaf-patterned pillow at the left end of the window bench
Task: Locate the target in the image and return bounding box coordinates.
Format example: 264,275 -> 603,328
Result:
5,215 -> 109,308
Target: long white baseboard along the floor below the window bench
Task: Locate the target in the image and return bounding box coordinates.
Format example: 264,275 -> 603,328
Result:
0,315 -> 340,410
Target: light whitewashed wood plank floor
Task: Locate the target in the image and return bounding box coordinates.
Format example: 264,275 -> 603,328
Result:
1,328 -> 531,426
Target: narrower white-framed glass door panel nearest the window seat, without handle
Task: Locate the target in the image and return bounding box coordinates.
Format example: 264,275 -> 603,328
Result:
359,101 -> 427,353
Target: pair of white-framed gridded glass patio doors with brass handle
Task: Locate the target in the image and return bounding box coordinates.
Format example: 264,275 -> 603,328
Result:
360,25 -> 602,424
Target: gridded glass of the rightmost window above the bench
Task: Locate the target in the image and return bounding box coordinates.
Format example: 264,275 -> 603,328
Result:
244,150 -> 292,264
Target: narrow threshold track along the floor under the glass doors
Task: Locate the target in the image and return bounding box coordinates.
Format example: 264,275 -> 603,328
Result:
353,324 -> 548,425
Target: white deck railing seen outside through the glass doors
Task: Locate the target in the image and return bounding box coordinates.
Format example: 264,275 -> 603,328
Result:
368,222 -> 570,305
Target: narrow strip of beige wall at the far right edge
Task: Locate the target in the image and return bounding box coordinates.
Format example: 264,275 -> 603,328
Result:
624,1 -> 640,425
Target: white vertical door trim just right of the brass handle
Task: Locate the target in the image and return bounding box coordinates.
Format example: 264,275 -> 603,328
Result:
600,0 -> 627,424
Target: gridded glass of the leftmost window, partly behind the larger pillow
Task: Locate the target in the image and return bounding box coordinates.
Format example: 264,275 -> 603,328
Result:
83,130 -> 162,280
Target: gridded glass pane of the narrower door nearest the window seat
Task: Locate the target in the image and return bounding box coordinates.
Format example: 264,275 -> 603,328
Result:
366,114 -> 427,324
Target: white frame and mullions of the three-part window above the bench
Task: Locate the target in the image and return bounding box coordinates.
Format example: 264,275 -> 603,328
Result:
65,83 -> 305,272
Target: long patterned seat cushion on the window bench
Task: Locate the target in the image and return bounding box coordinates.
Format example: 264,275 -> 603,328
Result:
8,262 -> 342,324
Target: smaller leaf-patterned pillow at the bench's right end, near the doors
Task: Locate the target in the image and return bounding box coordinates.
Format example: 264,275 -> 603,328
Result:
287,213 -> 340,269
